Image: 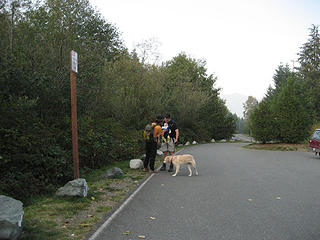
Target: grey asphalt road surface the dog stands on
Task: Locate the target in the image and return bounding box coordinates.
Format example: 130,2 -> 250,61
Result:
86,143 -> 320,240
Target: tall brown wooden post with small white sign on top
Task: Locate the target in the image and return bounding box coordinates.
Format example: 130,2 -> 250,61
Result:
70,50 -> 80,179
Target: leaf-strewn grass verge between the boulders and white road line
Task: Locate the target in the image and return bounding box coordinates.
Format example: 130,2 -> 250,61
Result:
20,156 -> 162,240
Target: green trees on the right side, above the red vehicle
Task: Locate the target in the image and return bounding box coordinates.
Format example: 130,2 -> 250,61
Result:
238,25 -> 320,144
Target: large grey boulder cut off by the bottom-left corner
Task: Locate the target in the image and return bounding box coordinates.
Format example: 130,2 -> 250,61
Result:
0,195 -> 24,240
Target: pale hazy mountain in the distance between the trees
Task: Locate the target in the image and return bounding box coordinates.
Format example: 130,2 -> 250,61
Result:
220,93 -> 248,117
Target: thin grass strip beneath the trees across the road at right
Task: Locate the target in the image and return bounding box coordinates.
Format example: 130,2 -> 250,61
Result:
243,143 -> 309,152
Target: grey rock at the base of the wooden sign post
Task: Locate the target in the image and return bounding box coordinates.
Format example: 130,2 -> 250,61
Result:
56,178 -> 89,197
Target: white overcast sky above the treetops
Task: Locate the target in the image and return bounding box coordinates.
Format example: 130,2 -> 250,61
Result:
90,0 -> 320,100
